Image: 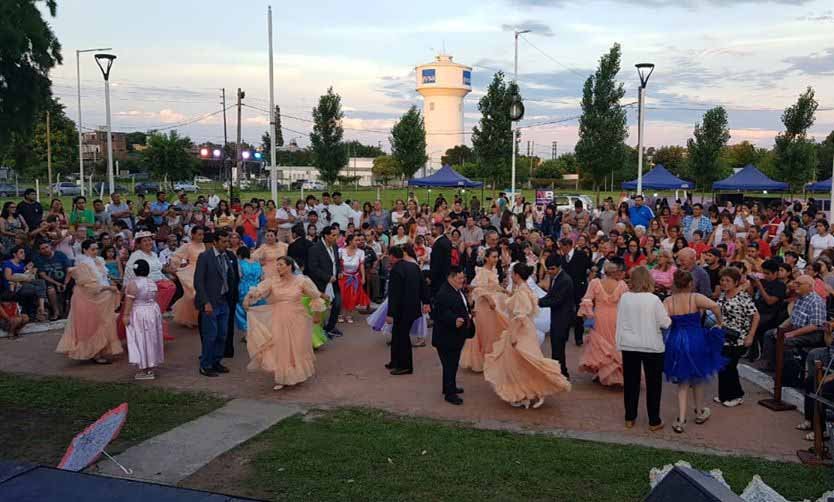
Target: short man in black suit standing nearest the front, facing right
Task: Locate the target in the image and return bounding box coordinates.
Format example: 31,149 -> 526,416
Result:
431,267 -> 475,405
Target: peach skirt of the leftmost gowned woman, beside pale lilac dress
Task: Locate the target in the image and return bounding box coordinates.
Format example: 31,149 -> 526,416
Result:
55,287 -> 124,361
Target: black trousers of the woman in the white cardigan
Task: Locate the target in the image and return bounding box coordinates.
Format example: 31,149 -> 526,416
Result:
623,350 -> 663,425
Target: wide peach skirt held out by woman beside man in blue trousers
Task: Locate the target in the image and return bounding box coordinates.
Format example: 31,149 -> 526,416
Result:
246,302 -> 316,385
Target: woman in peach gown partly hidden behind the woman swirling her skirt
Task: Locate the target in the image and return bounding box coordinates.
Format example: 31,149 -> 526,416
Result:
460,248 -> 507,373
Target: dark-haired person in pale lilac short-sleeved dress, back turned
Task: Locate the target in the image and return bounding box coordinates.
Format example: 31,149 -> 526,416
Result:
122,260 -> 165,380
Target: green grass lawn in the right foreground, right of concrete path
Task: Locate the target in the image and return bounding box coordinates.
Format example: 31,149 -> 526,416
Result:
203,410 -> 831,501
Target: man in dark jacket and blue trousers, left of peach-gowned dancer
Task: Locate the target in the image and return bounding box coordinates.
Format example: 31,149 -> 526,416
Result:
194,230 -> 237,377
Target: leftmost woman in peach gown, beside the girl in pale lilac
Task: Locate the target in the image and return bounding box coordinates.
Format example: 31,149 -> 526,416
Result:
55,239 -> 124,364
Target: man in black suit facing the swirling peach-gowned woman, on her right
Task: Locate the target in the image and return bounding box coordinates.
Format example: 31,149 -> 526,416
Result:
539,253 -> 576,378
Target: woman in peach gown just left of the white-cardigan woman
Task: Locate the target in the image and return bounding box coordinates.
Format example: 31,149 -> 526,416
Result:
579,261 -> 628,385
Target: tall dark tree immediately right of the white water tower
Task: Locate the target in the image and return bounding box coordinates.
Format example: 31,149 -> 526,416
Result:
472,71 -> 519,183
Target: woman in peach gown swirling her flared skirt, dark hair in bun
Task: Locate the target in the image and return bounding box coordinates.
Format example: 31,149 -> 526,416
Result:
484,263 -> 570,408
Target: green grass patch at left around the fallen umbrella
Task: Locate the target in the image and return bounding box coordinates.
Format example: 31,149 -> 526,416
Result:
0,373 -> 225,465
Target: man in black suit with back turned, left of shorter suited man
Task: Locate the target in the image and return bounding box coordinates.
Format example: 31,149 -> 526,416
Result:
385,247 -> 426,375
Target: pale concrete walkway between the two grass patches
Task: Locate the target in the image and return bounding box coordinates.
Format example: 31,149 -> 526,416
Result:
90,399 -> 302,485
